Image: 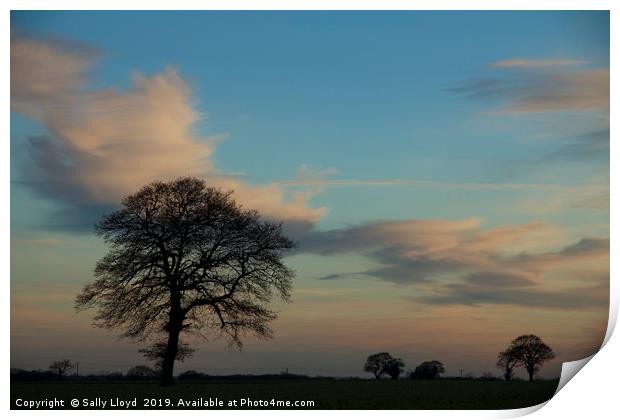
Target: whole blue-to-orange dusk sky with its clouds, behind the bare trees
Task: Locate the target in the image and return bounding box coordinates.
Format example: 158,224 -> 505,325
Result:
10,11 -> 609,377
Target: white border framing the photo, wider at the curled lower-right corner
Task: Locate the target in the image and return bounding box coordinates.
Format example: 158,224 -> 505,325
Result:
0,0 -> 620,420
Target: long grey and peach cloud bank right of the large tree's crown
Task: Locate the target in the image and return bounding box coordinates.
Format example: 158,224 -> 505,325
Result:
299,219 -> 609,308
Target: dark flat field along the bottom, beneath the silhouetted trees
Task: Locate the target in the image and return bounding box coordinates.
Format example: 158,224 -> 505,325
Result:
11,379 -> 558,410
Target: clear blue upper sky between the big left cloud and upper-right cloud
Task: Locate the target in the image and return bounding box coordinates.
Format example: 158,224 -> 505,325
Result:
13,12 -> 609,230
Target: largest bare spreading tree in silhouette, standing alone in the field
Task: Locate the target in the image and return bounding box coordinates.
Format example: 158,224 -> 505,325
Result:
76,177 -> 294,384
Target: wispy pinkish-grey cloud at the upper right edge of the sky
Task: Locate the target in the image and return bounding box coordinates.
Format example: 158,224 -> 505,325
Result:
449,58 -> 610,172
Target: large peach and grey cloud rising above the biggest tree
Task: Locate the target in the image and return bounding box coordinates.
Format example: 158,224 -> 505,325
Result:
11,38 -> 325,230
